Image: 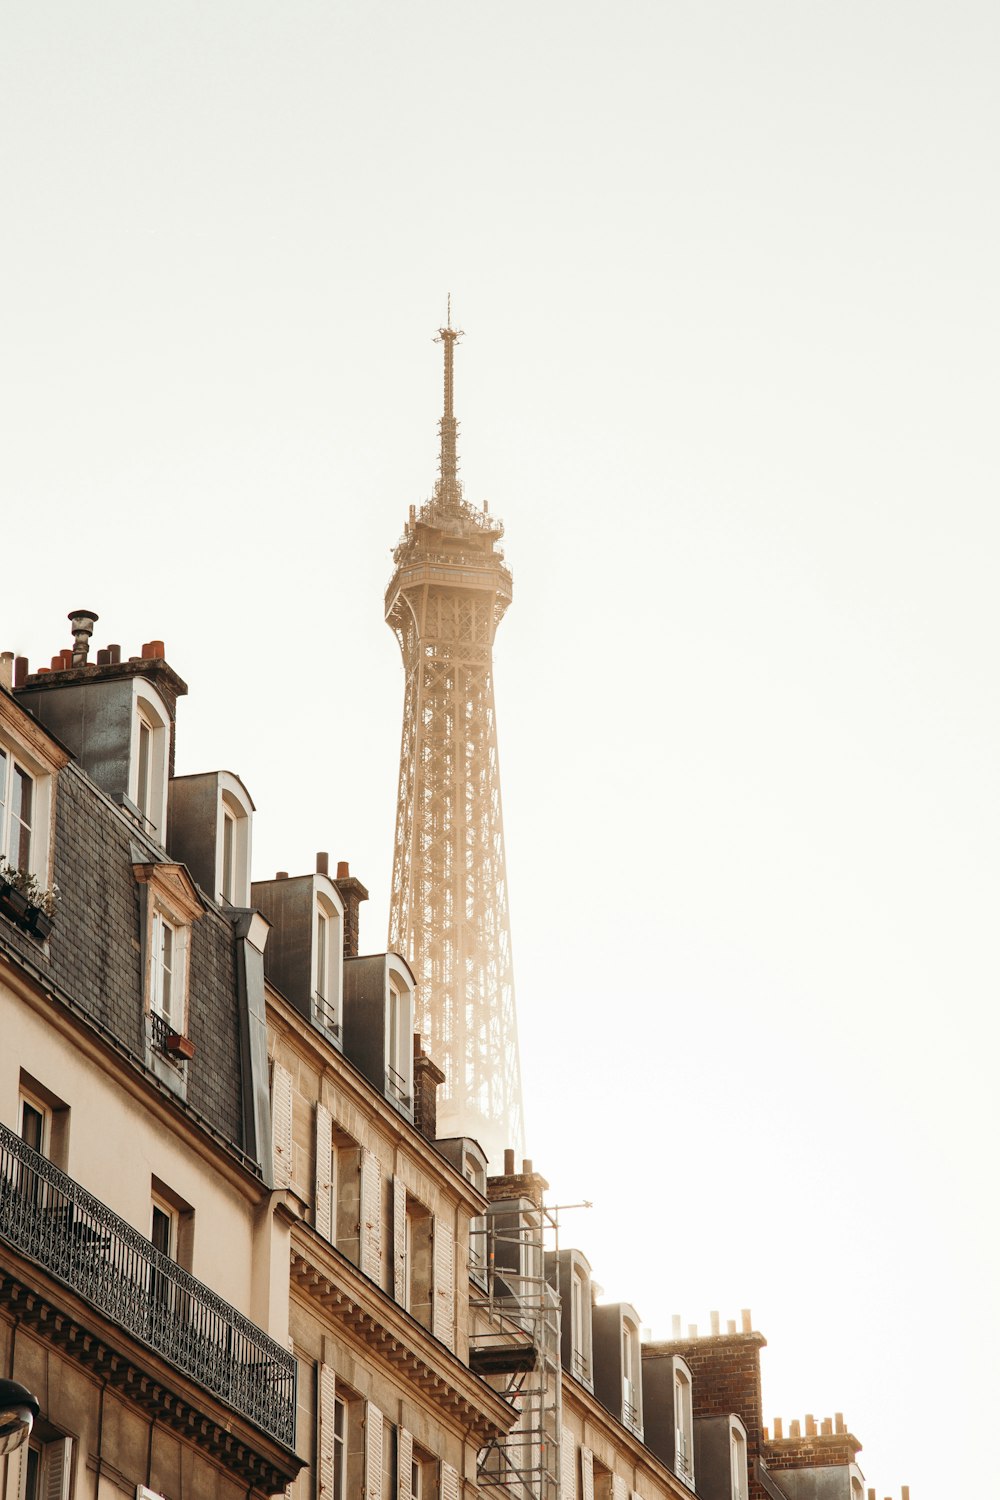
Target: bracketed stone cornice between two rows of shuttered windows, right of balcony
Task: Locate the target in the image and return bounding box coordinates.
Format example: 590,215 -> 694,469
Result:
291,1230 -> 517,1446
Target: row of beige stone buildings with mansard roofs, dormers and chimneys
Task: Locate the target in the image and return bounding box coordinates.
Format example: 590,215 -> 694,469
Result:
0,612 -> 907,1500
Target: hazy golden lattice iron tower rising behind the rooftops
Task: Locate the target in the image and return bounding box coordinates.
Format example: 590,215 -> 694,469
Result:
385,306 -> 523,1170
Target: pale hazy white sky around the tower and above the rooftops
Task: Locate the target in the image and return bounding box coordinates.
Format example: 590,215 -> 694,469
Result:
0,0 -> 1000,1500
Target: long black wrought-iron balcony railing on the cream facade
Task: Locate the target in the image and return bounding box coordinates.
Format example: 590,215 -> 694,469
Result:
0,1125 -> 295,1448
